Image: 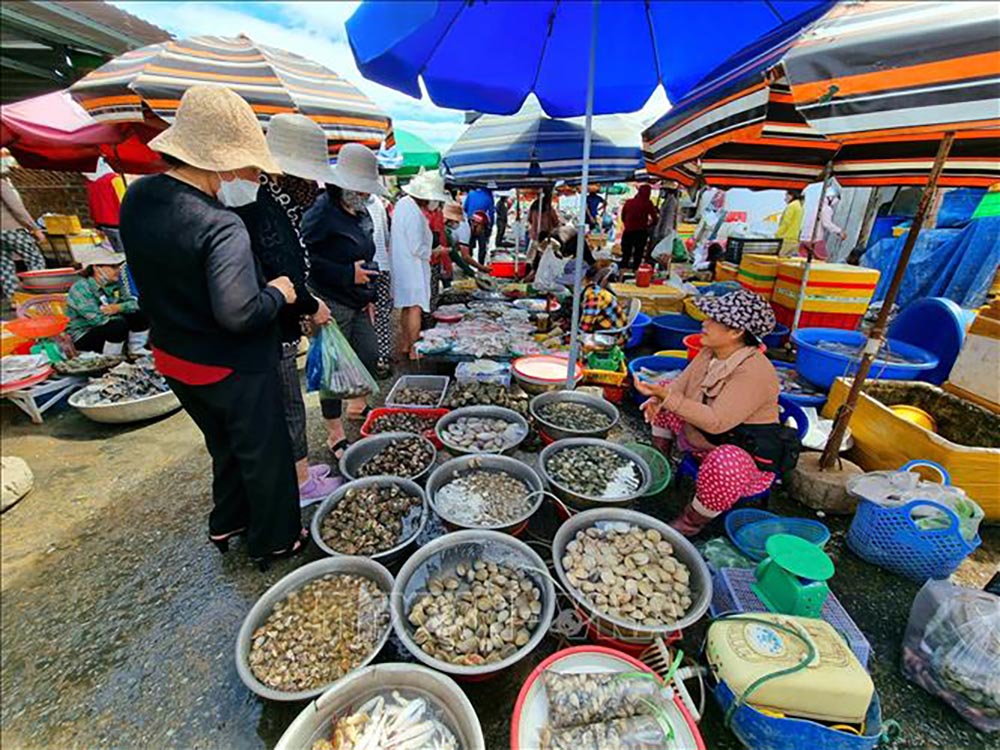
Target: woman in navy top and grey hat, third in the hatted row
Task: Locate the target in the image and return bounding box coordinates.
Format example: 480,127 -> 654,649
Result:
302,143 -> 386,459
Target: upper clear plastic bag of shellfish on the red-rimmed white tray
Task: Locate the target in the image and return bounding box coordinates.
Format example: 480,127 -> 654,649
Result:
542,671 -> 670,729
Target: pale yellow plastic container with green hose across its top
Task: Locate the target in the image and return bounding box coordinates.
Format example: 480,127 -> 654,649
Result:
705,613 -> 875,725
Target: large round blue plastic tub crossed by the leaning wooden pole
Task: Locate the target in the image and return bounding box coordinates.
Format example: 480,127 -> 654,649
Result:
792,328 -> 938,388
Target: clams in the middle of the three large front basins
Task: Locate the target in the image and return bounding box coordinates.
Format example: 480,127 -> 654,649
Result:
406,560 -> 542,666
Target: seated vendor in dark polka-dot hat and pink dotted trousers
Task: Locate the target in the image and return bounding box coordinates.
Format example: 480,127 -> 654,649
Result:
636,289 -> 798,536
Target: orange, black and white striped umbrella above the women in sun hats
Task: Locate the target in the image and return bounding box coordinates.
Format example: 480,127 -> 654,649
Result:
70,36 -> 393,158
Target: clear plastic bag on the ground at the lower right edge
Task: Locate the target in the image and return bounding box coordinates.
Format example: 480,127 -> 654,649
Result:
902,581 -> 1000,732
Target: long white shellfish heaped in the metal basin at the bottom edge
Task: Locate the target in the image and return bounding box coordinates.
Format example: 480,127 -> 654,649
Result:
312,690 -> 459,750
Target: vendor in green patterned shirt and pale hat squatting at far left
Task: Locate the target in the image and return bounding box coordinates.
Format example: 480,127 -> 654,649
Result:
66,247 -> 150,355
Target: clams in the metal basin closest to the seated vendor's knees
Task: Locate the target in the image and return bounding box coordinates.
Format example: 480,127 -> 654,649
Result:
545,445 -> 643,500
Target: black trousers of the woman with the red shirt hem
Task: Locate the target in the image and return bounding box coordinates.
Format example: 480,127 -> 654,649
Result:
167,367 -> 302,557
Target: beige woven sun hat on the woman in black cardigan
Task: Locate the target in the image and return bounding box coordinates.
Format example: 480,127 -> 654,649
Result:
149,85 -> 281,174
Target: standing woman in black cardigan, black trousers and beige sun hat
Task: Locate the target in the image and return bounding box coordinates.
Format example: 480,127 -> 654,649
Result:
121,86 -> 308,567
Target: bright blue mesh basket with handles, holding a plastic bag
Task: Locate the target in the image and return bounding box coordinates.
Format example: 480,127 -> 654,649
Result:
847,499 -> 981,583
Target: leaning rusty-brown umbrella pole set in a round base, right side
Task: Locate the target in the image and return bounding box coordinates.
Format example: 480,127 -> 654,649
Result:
819,132 -> 955,469
